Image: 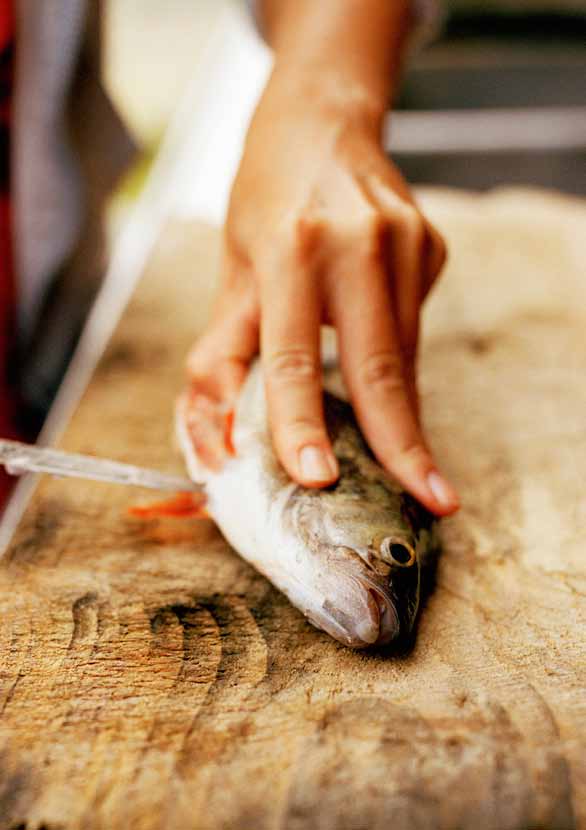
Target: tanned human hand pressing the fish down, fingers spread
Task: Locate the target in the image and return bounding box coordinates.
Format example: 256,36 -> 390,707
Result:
188,70 -> 458,515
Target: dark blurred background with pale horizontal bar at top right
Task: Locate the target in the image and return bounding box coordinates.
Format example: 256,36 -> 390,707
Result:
391,0 -> 586,194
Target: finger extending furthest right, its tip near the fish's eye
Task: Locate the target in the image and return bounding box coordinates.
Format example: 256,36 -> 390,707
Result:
333,250 -> 458,515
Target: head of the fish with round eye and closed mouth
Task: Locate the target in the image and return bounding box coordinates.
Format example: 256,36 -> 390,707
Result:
294,448 -> 433,648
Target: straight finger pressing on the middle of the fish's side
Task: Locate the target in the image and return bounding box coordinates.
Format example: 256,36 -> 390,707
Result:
261,250 -> 339,487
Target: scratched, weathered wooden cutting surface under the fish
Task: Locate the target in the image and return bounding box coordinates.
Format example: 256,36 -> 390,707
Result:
0,191 -> 586,830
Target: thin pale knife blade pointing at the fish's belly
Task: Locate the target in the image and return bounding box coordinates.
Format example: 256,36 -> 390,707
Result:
0,439 -> 204,492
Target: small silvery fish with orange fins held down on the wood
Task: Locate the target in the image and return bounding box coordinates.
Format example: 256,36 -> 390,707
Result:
176,338 -> 438,649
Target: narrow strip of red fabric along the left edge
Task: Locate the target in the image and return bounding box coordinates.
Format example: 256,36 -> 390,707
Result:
0,0 -> 18,511
